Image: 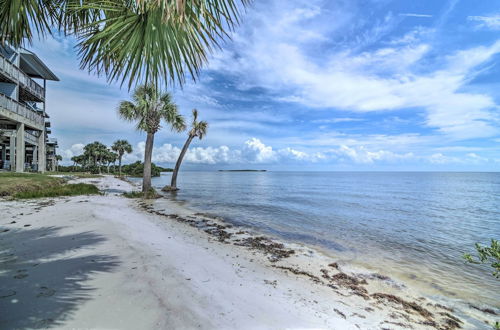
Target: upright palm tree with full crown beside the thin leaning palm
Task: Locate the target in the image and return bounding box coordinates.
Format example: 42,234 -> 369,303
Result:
118,84 -> 186,194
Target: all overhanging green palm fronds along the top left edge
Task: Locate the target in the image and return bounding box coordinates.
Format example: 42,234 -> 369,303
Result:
0,0 -> 250,89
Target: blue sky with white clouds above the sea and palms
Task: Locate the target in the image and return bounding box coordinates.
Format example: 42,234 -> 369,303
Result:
29,0 -> 500,171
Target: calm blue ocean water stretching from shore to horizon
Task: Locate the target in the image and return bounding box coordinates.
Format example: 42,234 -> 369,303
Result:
144,171 -> 500,308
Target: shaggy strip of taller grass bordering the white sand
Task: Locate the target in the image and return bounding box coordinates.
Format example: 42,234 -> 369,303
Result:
13,183 -> 99,199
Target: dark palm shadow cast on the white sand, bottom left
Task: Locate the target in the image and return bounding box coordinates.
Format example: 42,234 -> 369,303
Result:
0,227 -> 119,329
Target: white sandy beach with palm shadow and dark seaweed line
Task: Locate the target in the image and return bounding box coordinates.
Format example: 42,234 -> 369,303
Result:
0,176 -> 494,329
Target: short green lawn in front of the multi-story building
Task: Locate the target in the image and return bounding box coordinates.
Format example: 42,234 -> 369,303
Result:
0,172 -> 66,196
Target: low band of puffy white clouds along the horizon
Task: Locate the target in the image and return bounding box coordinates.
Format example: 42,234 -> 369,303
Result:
61,138 -> 498,166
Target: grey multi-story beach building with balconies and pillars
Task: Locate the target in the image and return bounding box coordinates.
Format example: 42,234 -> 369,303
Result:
0,45 -> 59,172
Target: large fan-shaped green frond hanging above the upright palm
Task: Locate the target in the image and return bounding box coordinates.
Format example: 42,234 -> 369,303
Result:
74,0 -> 249,89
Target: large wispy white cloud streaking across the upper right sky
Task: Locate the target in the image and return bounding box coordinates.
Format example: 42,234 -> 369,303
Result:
210,1 -> 500,140
